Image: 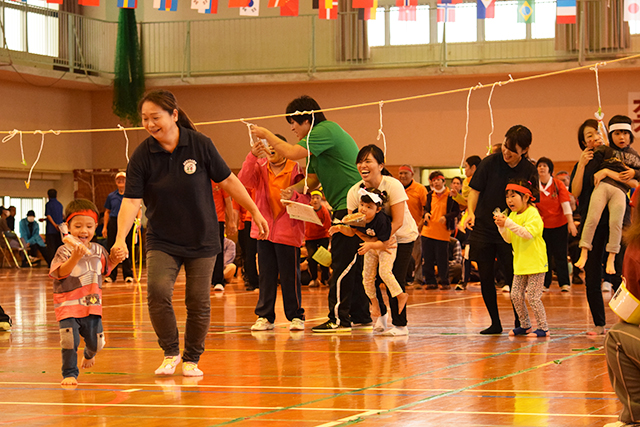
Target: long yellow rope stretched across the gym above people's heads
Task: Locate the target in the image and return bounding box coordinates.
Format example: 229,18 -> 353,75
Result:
0,54 -> 640,134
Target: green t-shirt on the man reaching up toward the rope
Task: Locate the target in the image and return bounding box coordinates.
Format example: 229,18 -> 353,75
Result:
298,120 -> 361,211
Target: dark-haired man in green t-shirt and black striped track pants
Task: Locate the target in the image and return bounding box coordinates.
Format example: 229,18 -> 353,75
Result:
251,95 -> 371,332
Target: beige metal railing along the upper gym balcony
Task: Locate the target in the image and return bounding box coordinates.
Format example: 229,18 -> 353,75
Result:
0,0 -> 640,78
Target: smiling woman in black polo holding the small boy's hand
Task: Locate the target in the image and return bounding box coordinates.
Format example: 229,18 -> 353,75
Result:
113,90 -> 269,376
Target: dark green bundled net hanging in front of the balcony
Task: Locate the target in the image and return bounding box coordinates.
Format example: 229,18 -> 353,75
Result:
113,8 -> 144,126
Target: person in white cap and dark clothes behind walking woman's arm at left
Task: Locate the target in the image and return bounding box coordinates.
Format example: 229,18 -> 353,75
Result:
102,172 -> 134,283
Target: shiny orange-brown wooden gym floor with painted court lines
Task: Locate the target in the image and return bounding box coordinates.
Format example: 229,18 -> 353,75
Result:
0,268 -> 621,427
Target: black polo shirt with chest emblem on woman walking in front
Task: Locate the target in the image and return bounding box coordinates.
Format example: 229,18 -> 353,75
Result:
124,123 -> 231,258
